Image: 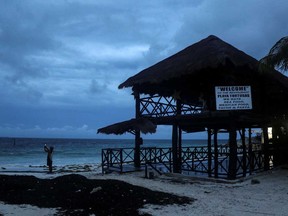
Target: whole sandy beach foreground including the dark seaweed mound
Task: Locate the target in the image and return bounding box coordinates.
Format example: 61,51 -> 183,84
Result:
0,168 -> 288,216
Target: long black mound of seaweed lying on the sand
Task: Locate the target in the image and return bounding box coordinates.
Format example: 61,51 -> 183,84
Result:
0,174 -> 193,216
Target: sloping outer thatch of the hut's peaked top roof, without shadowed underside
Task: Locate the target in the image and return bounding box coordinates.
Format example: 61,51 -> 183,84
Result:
119,35 -> 288,93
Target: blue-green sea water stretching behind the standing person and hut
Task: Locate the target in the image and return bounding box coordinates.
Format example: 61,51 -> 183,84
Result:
0,138 -> 225,171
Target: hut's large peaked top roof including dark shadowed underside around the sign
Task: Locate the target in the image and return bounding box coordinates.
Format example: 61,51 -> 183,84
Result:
119,35 -> 288,112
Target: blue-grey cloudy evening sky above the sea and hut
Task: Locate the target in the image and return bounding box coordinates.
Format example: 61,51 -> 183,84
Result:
0,0 -> 288,138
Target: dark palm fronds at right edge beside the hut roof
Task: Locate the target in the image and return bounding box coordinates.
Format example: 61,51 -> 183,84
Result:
260,36 -> 288,71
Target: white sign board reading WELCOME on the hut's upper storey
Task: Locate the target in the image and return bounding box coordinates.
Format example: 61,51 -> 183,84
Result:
215,86 -> 252,110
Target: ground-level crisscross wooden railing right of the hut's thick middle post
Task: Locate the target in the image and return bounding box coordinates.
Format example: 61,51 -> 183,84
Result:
182,146 -> 273,177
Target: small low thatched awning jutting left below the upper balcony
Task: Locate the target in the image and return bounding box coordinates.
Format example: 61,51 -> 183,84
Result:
97,118 -> 157,135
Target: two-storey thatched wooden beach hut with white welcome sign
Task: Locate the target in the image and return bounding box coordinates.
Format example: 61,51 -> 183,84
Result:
98,35 -> 288,179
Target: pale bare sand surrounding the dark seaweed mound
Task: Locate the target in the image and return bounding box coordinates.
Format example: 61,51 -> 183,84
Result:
0,169 -> 288,216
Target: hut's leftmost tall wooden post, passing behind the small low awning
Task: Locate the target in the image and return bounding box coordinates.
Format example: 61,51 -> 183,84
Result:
134,91 -> 142,168
